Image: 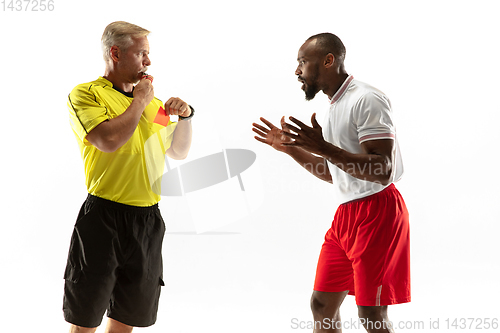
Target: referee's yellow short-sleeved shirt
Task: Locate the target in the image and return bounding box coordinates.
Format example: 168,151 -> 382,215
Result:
68,77 -> 177,206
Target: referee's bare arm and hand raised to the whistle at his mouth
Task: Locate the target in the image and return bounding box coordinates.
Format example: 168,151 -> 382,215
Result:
87,79 -> 154,153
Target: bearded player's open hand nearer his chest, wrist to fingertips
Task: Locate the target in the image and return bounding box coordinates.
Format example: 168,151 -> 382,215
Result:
282,113 -> 326,155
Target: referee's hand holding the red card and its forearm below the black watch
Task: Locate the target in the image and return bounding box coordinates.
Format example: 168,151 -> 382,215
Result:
165,97 -> 193,160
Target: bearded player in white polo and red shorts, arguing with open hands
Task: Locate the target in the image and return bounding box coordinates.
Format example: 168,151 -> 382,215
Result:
253,33 -> 410,333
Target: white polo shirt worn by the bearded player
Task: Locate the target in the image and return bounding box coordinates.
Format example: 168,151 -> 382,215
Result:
323,75 -> 403,203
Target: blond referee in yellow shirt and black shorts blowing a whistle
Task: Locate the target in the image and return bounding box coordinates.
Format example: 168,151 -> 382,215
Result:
63,21 -> 194,333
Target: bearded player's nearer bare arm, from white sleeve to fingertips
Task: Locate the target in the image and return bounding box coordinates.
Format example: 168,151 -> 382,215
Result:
282,113 -> 394,185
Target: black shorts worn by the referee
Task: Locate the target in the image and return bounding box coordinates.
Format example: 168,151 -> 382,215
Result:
63,194 -> 165,327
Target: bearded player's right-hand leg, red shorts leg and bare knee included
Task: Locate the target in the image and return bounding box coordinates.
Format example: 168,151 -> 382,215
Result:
350,185 -> 410,333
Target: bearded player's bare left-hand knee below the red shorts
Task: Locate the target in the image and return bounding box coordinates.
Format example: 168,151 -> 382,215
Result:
311,290 -> 348,333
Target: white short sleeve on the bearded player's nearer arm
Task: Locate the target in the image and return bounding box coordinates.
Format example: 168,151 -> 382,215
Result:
353,92 -> 396,144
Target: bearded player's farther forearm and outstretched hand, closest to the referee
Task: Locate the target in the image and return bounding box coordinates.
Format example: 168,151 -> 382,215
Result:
252,117 -> 332,183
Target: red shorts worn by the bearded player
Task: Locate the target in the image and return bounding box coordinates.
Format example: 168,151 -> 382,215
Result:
314,184 -> 411,306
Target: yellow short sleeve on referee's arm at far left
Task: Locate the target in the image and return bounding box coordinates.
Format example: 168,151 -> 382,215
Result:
68,85 -> 109,145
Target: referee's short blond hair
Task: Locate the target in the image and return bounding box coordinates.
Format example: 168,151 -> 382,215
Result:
101,21 -> 150,62
